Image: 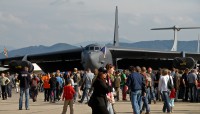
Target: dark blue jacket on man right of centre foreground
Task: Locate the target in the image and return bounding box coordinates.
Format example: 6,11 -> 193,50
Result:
127,72 -> 145,92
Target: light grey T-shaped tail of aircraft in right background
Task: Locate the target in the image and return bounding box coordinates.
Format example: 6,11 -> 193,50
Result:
151,26 -> 200,51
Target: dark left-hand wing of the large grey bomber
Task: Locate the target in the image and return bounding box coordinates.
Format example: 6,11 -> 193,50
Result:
0,48 -> 82,72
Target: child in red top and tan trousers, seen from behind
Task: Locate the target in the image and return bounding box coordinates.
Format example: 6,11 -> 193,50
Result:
62,80 -> 75,114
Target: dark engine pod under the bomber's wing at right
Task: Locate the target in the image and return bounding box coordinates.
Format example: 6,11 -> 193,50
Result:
173,57 -> 195,70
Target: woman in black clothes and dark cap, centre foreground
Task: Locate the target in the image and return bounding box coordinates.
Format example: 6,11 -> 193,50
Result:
90,67 -> 110,114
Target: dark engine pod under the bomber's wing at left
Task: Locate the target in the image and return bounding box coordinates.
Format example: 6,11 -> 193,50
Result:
9,60 -> 34,72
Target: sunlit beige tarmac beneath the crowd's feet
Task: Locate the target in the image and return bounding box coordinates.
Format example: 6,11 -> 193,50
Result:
0,92 -> 200,114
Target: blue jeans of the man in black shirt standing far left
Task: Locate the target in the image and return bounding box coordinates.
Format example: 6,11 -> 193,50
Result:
19,87 -> 29,109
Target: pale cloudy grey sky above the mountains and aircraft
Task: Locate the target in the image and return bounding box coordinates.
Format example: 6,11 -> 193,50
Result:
0,0 -> 200,48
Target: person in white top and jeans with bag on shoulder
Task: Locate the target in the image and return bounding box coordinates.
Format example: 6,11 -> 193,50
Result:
158,69 -> 173,113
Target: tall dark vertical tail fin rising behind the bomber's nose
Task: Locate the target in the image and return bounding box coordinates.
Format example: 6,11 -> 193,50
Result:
113,6 -> 119,47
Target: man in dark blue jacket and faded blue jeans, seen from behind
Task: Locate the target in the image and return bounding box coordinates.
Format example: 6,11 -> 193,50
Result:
127,67 -> 146,114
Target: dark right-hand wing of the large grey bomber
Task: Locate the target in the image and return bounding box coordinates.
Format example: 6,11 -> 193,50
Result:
109,47 -> 200,69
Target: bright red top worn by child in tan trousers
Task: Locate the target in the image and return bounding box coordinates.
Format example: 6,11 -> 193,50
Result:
63,85 -> 75,100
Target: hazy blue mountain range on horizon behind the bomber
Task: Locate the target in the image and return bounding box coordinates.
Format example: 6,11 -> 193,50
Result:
0,40 -> 198,58
